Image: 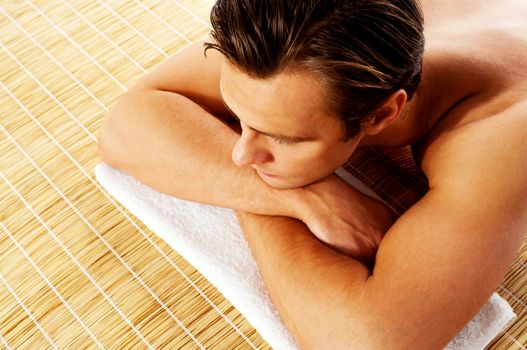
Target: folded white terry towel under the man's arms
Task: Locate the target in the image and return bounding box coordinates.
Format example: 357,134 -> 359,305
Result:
94,163 -> 516,350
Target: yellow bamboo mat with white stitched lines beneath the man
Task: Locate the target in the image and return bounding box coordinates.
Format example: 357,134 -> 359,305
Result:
0,0 -> 527,349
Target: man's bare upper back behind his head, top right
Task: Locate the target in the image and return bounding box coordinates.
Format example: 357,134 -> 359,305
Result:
412,0 -> 527,180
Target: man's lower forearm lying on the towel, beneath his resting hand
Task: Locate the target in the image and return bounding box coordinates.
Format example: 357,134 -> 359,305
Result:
237,212 -> 372,349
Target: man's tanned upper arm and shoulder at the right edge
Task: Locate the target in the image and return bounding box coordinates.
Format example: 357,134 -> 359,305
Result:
364,101 -> 527,349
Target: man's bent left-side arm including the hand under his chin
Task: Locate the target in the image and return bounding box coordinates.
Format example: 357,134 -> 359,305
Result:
99,44 -> 391,254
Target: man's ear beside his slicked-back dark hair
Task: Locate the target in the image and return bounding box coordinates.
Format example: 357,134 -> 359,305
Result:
363,89 -> 408,135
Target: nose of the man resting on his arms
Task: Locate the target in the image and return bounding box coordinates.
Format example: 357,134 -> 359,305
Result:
232,130 -> 270,167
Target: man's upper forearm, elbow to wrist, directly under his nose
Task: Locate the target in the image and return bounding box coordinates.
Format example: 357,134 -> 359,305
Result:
99,89 -> 300,216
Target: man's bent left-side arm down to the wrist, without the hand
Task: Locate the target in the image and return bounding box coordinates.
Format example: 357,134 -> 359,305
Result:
99,44 -> 296,216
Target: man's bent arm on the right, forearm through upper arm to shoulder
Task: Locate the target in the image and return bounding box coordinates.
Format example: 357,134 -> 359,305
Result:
237,111 -> 527,350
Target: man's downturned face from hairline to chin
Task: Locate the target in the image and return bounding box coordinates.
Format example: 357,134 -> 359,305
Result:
220,62 -> 362,189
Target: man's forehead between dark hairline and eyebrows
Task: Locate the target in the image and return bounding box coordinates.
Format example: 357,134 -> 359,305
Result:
220,61 -> 340,137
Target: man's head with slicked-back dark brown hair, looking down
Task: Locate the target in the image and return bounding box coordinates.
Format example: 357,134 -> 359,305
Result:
206,0 -> 424,188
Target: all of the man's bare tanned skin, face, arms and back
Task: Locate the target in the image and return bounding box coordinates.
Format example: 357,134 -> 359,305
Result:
100,1 -> 527,349
